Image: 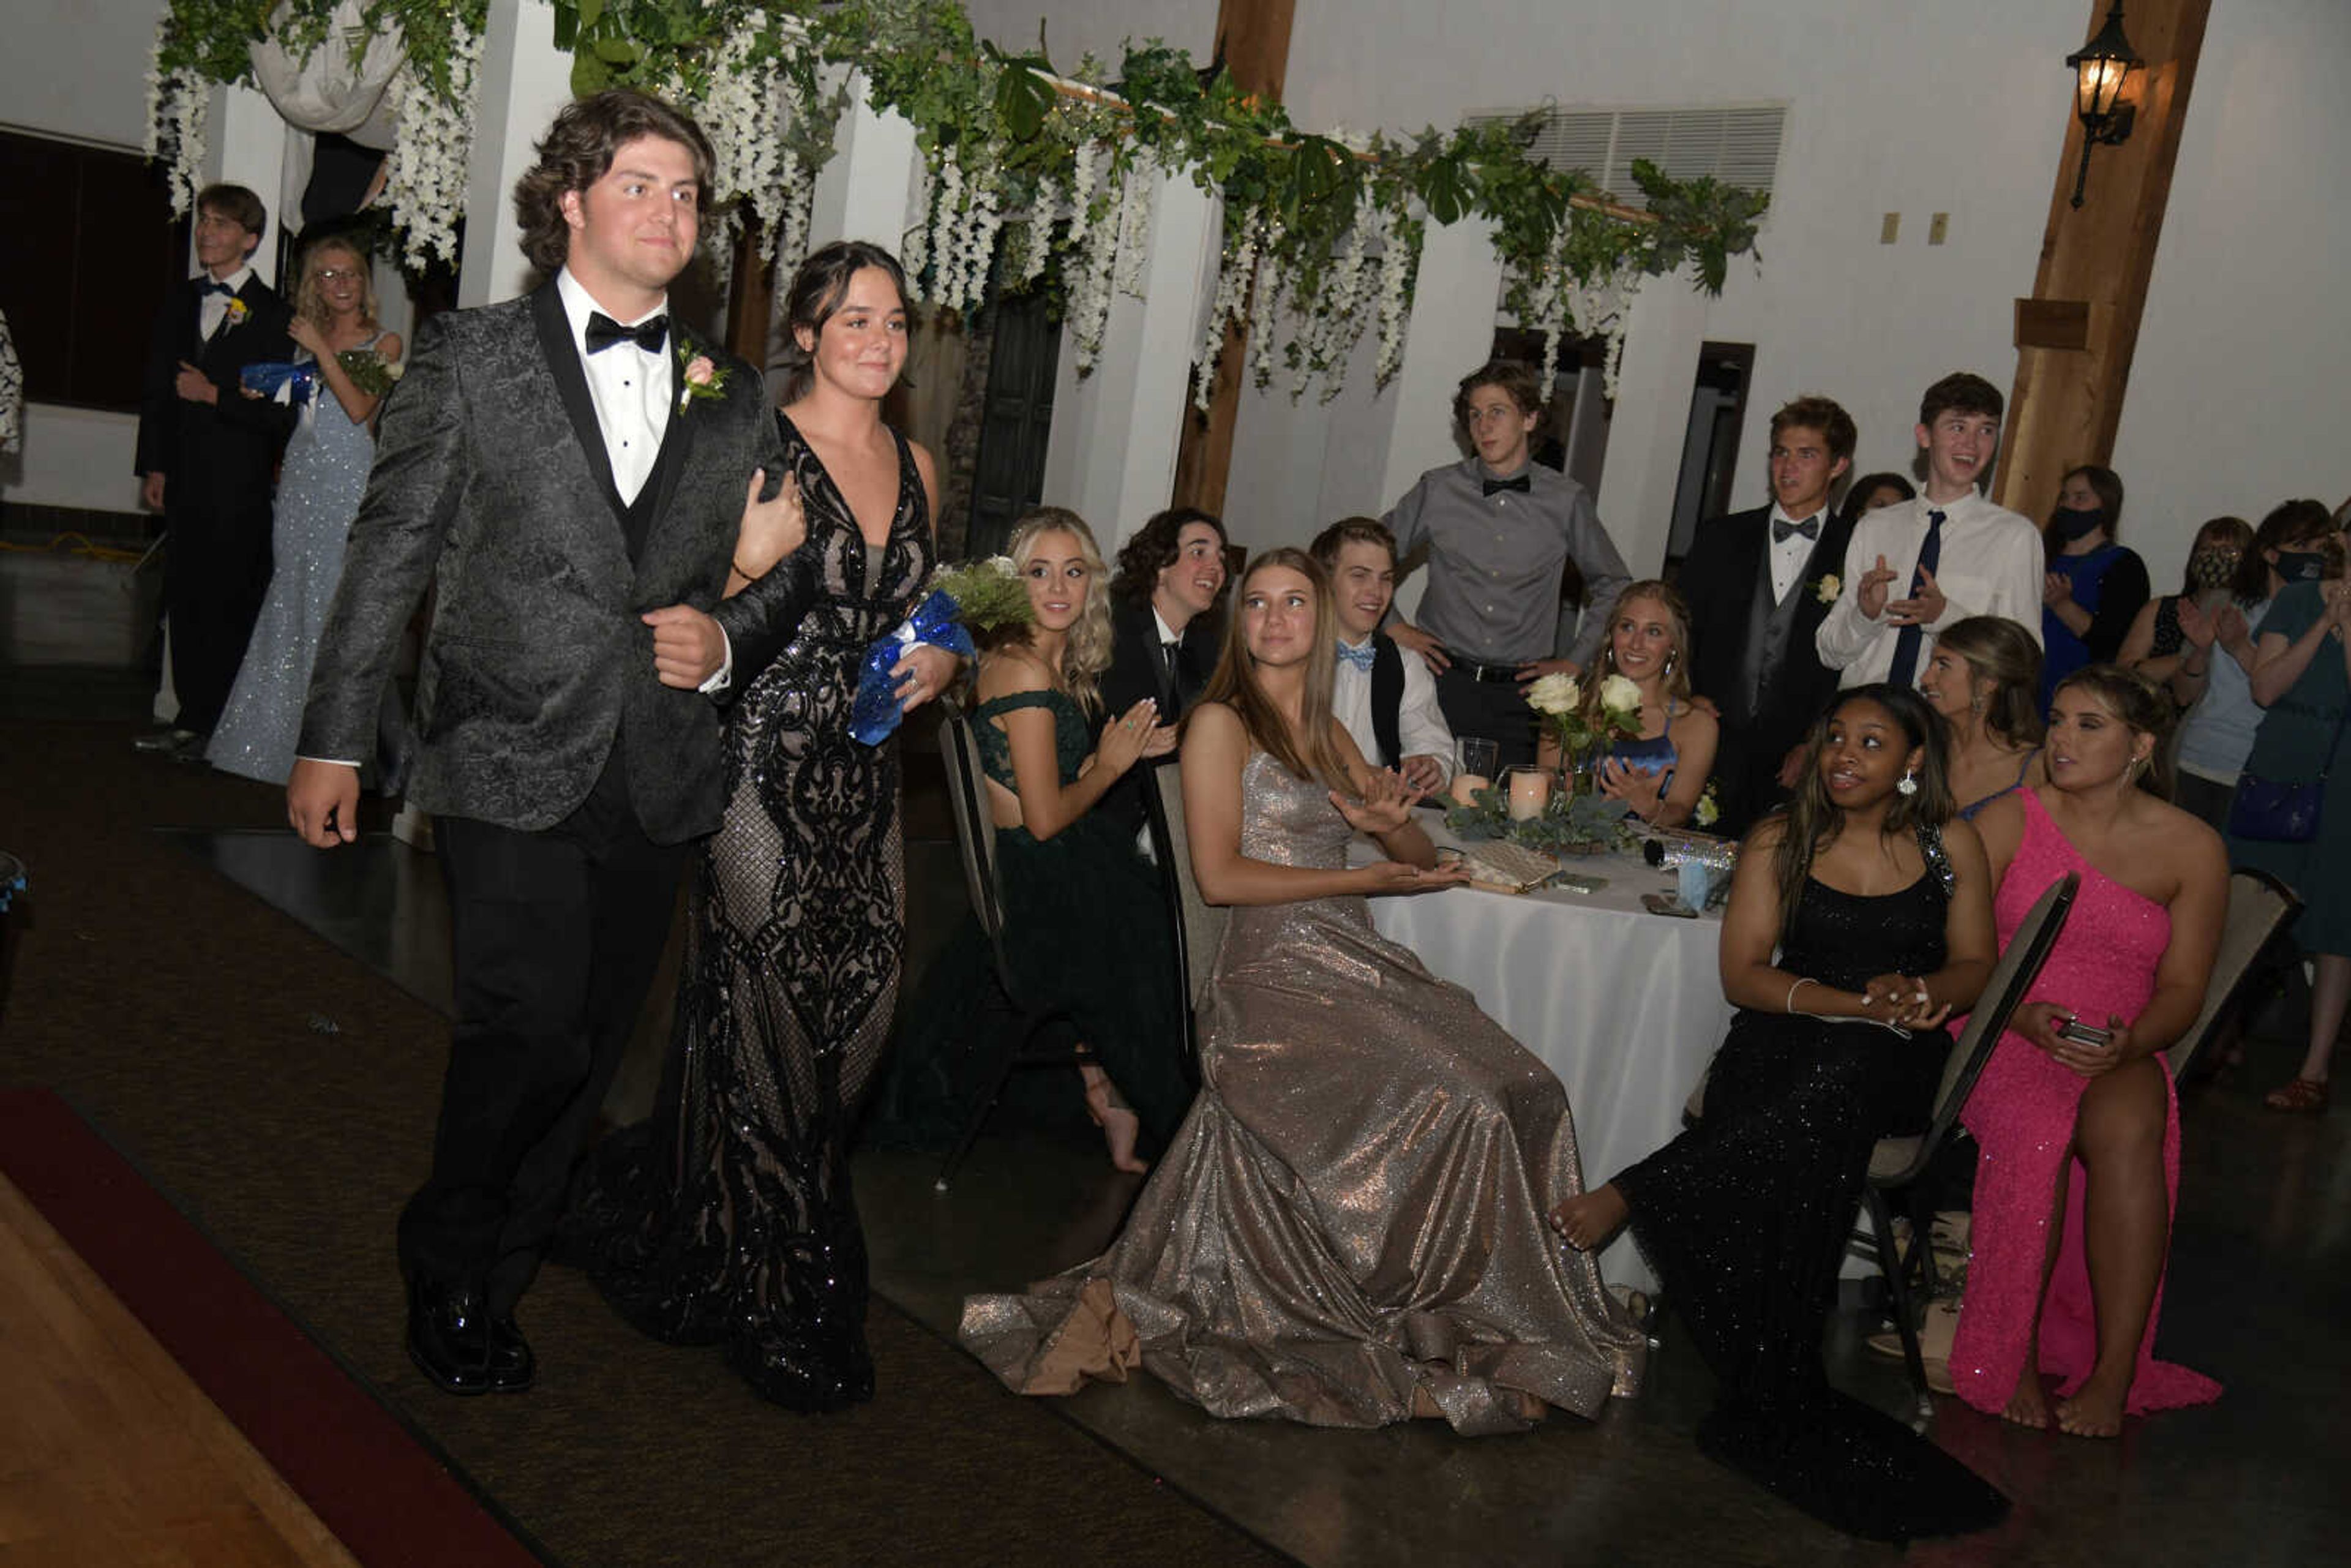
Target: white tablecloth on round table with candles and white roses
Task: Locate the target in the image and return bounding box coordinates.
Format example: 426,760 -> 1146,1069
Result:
1371,841 -> 1730,1291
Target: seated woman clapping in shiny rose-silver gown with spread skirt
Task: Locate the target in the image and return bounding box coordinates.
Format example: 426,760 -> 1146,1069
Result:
962,550 -> 1646,1434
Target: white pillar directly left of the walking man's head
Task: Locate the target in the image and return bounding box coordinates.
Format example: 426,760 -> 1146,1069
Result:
456,0 -> 571,306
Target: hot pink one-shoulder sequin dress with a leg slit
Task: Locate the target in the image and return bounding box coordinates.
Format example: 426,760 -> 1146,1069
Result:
1951,790 -> 2219,1415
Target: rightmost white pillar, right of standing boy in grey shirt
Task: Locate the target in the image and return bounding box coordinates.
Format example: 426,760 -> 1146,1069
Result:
1594,271 -> 1707,579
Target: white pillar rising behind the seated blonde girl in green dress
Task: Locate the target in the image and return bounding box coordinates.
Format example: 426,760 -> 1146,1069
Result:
1044,171 -> 1223,555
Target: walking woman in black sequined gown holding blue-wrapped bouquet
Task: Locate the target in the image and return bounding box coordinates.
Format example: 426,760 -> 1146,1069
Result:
569,242 -> 957,1411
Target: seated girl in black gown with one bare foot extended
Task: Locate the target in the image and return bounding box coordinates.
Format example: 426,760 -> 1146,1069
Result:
1551,686 -> 2008,1540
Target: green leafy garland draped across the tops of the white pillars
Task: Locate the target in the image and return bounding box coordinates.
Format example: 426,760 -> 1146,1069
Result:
157,0 -> 1768,392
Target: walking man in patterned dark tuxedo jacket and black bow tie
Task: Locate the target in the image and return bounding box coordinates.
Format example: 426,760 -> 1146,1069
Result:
287,89 -> 801,1394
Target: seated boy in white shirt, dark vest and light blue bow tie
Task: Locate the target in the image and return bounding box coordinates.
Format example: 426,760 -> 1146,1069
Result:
1307,517 -> 1453,792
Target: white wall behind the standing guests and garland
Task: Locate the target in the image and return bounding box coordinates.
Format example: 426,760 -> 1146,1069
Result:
973,0 -> 2351,583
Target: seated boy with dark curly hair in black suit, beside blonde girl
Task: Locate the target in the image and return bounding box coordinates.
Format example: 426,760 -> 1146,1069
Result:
1095,506 -> 1225,832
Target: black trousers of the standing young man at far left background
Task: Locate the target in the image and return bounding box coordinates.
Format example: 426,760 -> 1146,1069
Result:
162,496 -> 271,733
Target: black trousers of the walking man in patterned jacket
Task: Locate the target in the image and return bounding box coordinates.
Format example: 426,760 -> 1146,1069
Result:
400,743 -> 689,1314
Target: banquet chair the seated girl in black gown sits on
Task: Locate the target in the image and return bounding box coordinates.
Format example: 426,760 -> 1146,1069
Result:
1853,872 -> 2080,1415
